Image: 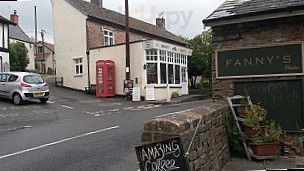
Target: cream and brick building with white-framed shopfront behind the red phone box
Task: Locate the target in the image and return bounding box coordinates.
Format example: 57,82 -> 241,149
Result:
52,0 -> 191,100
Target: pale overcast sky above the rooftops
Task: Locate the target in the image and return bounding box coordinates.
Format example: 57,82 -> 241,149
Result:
0,0 -> 225,43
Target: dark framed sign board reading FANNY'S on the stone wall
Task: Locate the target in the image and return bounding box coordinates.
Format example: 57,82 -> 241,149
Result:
216,44 -> 303,79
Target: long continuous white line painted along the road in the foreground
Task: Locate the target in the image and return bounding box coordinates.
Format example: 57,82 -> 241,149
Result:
0,126 -> 119,160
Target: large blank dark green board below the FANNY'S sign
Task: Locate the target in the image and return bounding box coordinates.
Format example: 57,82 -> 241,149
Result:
234,80 -> 304,132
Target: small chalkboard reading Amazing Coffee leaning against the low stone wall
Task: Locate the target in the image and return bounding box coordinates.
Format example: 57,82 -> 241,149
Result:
135,137 -> 189,171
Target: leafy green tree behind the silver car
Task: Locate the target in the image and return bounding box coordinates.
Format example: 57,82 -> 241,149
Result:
10,42 -> 29,71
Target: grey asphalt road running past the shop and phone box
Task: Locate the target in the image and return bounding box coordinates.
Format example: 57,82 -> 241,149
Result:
0,78 -> 211,171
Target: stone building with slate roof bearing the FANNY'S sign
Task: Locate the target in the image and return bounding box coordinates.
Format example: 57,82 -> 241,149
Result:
203,0 -> 304,154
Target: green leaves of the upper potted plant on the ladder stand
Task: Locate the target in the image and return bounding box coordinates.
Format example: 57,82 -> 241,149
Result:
243,105 -> 267,126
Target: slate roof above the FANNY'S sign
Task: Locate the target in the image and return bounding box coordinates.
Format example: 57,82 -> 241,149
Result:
203,0 -> 304,25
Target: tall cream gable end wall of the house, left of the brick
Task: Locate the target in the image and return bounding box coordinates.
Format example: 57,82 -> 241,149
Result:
51,0 -> 87,90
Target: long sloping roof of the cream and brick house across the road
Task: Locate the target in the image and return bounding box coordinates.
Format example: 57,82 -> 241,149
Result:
65,0 -> 185,44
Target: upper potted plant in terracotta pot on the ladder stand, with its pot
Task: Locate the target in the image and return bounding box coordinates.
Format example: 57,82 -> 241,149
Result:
243,105 -> 267,138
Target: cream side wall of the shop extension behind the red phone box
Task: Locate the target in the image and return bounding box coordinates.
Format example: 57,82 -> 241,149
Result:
90,42 -> 144,95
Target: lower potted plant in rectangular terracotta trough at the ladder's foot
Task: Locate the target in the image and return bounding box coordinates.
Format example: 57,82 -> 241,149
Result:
250,120 -> 283,156
